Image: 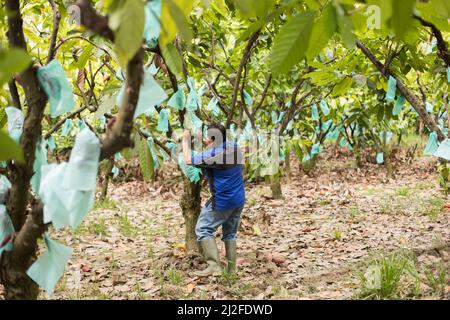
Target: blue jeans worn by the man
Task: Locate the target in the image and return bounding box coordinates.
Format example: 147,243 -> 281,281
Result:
195,203 -> 244,241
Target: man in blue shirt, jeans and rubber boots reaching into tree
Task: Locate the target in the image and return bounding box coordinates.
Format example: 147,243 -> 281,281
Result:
183,124 -> 245,277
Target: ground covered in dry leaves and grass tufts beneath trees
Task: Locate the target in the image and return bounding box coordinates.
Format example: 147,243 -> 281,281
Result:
10,145 -> 450,299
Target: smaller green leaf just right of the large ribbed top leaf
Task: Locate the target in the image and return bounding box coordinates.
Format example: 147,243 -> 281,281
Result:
306,4 -> 337,60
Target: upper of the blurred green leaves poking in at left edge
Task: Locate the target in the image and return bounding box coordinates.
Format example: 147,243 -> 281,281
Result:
0,48 -> 31,86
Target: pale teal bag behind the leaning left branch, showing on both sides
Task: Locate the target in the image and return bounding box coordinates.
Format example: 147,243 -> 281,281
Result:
117,70 -> 168,119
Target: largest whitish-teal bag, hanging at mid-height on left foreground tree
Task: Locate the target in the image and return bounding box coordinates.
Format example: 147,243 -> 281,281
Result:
39,128 -> 100,230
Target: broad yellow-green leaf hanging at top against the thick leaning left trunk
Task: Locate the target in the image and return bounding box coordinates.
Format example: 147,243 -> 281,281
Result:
108,0 -> 145,68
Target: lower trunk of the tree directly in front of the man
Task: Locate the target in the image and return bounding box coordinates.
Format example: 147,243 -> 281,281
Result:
180,178 -> 201,251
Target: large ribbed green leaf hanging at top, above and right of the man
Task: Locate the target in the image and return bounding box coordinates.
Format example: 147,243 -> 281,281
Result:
271,11 -> 316,76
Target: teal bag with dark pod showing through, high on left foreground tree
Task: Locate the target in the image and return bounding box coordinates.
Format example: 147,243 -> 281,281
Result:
37,60 -> 75,118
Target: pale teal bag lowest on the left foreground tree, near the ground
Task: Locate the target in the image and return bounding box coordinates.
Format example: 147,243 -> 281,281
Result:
27,234 -> 73,296
